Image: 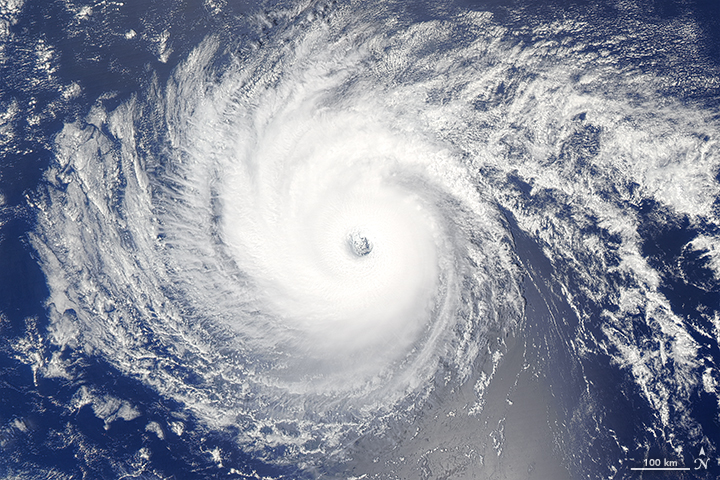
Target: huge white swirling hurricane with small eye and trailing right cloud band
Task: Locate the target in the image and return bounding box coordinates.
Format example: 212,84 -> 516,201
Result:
33,3 -> 720,472
